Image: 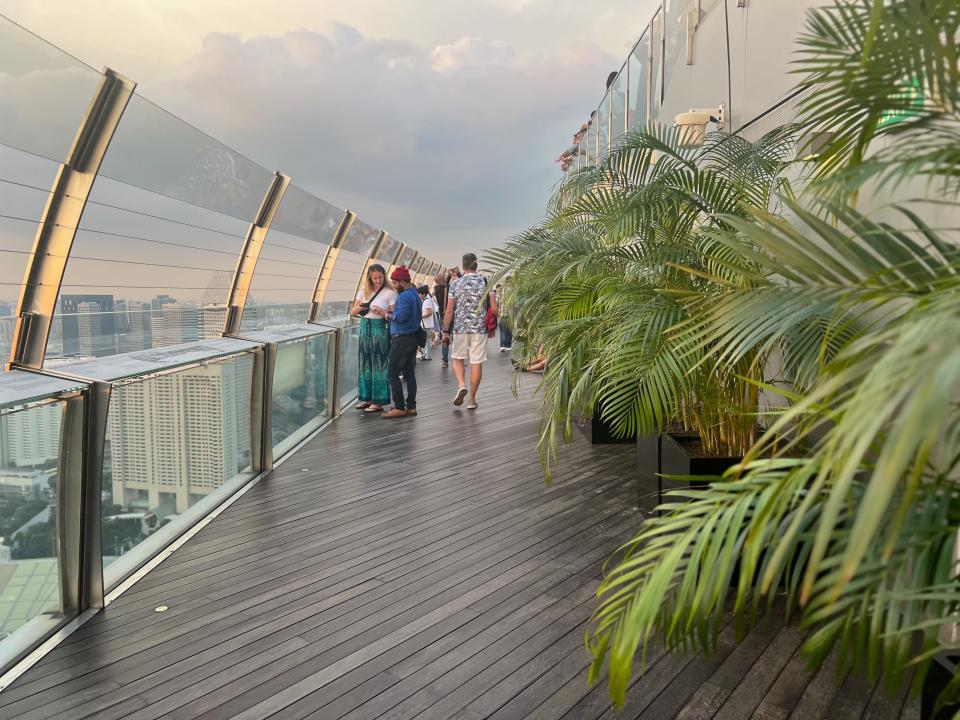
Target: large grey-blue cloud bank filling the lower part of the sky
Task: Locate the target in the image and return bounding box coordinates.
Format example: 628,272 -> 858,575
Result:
145,24 -> 616,264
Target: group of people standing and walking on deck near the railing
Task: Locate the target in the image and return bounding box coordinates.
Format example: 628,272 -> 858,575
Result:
351,253 -> 504,419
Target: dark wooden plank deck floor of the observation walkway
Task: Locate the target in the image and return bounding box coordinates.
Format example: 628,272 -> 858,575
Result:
0,343 -> 919,720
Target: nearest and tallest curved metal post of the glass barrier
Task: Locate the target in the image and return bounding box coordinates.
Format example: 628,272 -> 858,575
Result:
7,68 -> 136,368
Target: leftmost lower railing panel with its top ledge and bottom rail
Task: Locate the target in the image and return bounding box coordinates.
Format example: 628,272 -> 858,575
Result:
0,370 -> 83,668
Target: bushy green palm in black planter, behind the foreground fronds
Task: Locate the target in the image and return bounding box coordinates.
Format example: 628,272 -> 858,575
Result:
487,126 -> 794,477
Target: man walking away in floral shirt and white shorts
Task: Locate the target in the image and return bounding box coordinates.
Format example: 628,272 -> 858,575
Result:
443,253 -> 497,410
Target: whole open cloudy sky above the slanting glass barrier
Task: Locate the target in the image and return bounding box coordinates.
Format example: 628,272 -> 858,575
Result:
0,0 -> 658,278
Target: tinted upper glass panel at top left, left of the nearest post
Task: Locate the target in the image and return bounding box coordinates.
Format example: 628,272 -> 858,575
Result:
0,16 -> 102,164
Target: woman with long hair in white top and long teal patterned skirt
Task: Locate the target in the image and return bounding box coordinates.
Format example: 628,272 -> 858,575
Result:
350,265 -> 397,413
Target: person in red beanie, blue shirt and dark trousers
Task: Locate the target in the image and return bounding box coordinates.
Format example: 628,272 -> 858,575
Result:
383,265 -> 423,419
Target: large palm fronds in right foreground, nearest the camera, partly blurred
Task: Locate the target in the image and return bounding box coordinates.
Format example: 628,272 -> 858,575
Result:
588,0 -> 960,702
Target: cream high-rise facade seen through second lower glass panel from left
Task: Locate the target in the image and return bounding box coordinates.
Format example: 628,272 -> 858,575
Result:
109,357 -> 253,516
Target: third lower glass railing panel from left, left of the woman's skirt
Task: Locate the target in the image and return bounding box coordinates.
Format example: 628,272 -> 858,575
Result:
273,333 -> 334,458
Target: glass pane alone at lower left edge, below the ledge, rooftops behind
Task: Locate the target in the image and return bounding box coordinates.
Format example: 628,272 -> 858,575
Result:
0,401 -> 65,640
